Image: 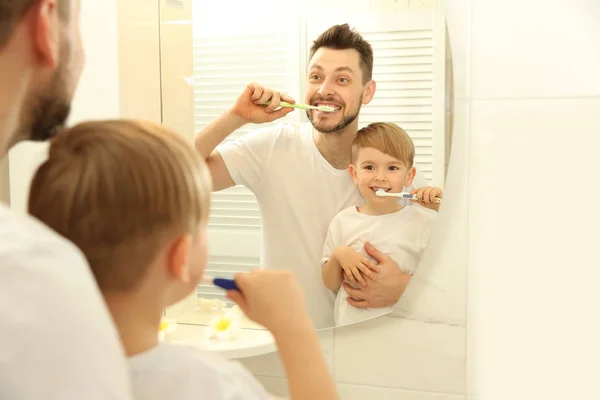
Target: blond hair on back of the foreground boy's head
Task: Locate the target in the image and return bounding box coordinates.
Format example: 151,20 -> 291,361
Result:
29,120 -> 212,291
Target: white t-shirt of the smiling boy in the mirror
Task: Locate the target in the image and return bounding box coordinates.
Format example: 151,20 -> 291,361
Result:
321,205 -> 435,326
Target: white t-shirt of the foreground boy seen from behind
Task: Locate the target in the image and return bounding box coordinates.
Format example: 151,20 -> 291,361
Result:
129,343 -> 269,400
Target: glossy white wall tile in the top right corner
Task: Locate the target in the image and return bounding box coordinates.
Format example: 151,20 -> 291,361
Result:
472,0 -> 600,99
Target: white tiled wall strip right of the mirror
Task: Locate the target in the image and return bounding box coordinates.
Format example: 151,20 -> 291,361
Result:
448,0 -> 600,400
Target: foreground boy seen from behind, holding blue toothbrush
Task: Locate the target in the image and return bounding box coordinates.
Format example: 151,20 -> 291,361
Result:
29,121 -> 337,400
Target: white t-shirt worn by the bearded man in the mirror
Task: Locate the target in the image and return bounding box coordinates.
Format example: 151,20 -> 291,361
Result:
218,122 -> 426,329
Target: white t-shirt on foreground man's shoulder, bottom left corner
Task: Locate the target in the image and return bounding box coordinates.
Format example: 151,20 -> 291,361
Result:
0,205 -> 132,400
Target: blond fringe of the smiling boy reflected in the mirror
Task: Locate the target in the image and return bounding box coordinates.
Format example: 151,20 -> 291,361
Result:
352,122 -> 415,168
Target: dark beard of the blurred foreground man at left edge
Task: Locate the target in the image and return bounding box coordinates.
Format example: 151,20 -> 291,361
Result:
26,46 -> 71,141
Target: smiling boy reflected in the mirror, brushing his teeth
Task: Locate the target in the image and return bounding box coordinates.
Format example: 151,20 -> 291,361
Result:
322,123 -> 442,326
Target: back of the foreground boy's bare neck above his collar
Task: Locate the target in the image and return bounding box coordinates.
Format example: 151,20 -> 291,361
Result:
103,293 -> 164,357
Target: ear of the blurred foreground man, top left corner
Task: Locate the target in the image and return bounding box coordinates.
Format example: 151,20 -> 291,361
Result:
24,0 -> 62,70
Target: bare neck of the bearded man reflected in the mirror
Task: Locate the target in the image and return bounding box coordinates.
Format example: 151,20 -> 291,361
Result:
313,120 -> 358,169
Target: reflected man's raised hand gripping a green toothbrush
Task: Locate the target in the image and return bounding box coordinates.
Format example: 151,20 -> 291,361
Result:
231,83 -> 296,124
